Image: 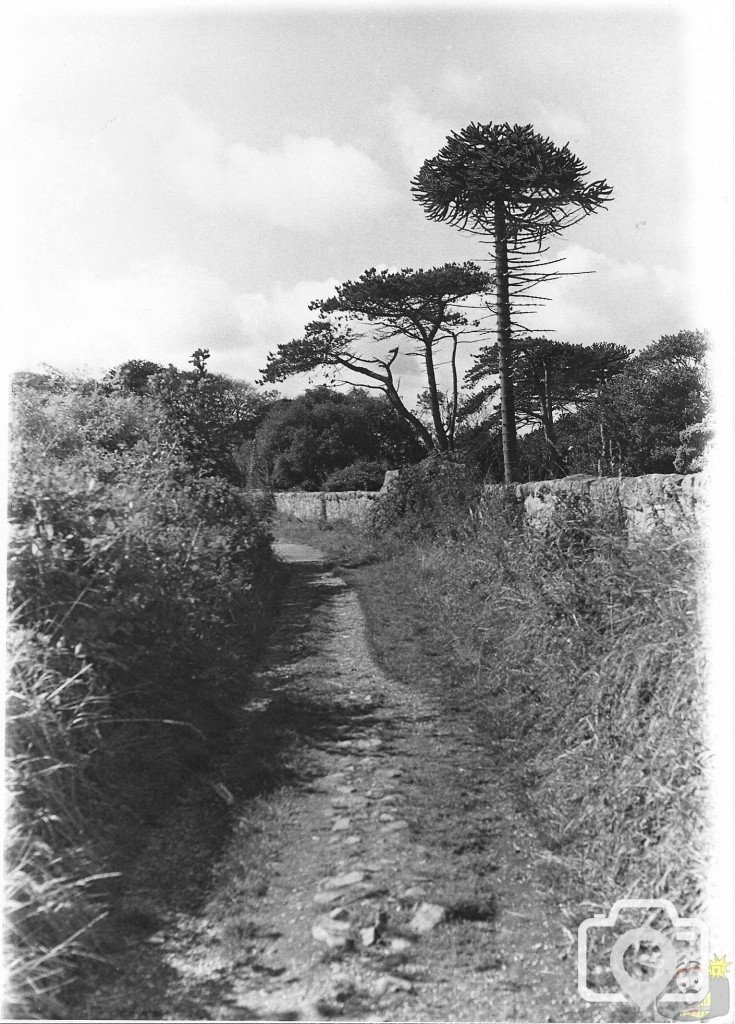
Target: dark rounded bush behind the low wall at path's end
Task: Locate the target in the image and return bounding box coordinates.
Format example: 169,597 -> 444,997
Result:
254,387 -> 423,490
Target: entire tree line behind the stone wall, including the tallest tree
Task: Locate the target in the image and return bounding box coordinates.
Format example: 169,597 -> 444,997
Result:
18,124 -> 710,489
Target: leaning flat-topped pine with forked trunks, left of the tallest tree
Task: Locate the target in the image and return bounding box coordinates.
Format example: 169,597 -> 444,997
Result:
261,263 -> 492,452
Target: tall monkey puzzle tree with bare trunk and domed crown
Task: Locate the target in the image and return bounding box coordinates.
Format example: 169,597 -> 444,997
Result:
412,123 -> 612,483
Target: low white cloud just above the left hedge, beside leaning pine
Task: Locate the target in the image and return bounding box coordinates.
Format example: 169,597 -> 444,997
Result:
12,256 -> 337,390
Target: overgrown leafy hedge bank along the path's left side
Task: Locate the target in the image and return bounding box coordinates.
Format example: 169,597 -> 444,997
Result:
5,380 -> 275,1018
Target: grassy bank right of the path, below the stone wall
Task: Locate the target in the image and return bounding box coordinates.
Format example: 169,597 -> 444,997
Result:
278,471 -> 706,926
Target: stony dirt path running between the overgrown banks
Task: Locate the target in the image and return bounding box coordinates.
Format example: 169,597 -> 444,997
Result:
73,543 -> 610,1021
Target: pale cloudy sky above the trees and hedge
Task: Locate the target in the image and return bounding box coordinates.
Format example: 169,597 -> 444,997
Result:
2,3 -> 732,399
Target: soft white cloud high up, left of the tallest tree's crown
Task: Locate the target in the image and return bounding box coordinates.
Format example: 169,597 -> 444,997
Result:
158,98 -> 393,233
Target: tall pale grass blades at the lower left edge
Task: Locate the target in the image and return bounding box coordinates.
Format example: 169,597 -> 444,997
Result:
5,629 -> 109,1016
